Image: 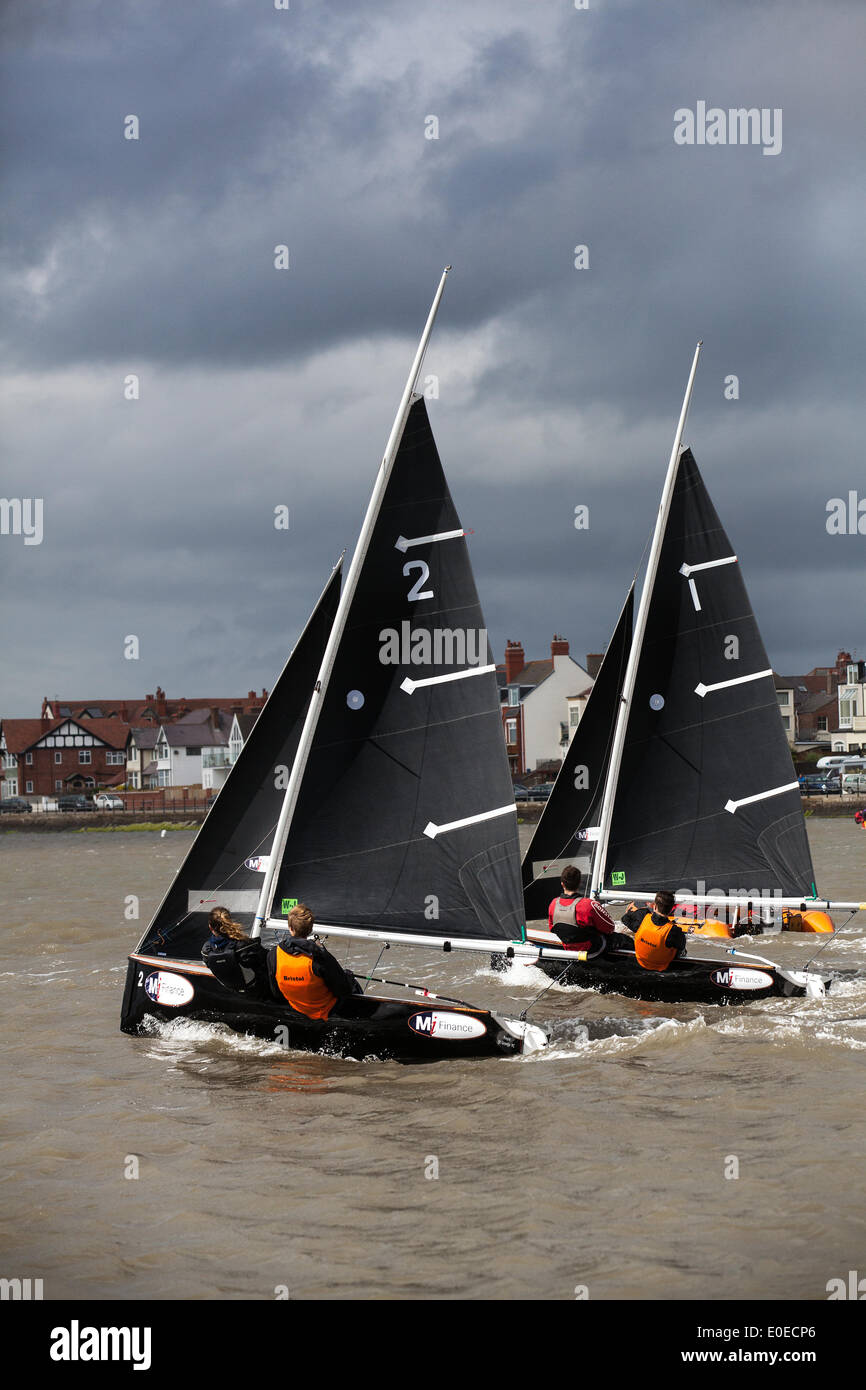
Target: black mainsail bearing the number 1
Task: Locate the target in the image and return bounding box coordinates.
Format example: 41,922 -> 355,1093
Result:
603,449 -> 815,897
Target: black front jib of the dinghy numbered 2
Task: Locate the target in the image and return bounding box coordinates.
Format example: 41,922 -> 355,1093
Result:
139,562 -> 342,960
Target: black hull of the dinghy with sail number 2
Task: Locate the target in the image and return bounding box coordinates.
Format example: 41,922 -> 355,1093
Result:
121,955 -> 534,1062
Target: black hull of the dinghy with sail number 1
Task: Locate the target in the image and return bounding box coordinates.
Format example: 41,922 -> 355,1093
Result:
511,951 -> 828,1004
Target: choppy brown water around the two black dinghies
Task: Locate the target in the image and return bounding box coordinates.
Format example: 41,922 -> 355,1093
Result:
0,820 -> 866,1300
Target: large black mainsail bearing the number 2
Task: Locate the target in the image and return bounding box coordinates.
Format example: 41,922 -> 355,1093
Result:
272,399 -> 524,940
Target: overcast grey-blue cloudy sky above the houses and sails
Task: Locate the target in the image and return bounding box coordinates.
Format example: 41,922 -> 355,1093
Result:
0,0 -> 866,717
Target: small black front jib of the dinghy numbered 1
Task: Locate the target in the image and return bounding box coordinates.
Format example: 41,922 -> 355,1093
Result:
523,585 -> 634,920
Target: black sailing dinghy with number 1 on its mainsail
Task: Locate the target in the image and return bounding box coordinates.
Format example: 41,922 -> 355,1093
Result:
523,345 -> 863,1004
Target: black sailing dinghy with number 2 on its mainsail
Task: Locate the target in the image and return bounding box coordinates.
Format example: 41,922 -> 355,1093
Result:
121,274 -> 546,1061
